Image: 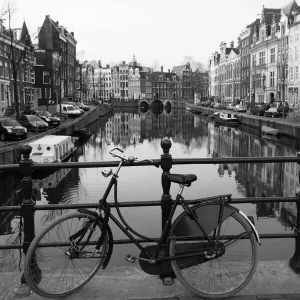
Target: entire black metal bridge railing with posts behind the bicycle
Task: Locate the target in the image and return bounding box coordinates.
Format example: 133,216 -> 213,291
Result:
0,139 -> 300,273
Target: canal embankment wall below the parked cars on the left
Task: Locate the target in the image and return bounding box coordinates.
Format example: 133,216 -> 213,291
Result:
0,105 -> 111,165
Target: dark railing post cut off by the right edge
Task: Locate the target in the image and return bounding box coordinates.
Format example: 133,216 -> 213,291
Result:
289,152 -> 300,273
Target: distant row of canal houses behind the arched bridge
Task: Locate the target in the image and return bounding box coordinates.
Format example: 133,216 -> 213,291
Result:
78,55 -> 208,101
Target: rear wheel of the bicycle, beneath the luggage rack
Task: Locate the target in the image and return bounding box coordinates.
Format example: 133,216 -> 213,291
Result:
169,202 -> 257,299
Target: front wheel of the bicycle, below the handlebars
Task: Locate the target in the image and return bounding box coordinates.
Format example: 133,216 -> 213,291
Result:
24,212 -> 108,298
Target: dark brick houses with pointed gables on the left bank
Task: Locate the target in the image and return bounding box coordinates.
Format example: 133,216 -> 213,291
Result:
0,15 -> 77,116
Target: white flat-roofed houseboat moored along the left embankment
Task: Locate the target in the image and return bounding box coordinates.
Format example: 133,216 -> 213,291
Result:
29,135 -> 75,163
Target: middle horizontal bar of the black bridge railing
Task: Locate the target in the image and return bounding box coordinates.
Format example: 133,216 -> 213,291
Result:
0,195 -> 299,212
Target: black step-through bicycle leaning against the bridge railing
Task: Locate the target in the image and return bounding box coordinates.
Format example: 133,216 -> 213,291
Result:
24,148 -> 260,299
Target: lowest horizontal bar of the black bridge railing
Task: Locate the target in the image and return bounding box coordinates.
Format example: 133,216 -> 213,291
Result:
0,233 -> 298,250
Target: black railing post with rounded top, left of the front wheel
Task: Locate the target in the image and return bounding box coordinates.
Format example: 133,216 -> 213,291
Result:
19,145 -> 35,283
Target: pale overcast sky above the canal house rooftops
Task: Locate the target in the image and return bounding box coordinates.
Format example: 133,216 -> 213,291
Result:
0,0 -> 290,70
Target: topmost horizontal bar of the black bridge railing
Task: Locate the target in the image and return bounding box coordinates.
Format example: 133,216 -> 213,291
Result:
0,156 -> 300,171
